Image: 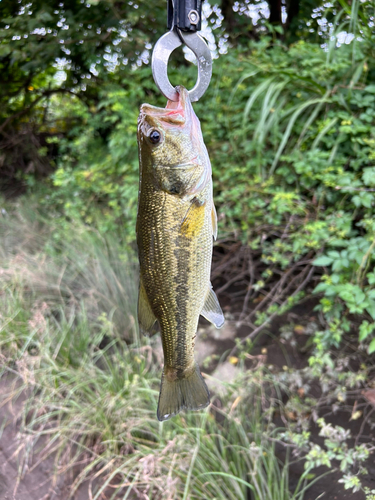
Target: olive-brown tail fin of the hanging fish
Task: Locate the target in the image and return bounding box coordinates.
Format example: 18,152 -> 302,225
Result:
157,363 -> 210,422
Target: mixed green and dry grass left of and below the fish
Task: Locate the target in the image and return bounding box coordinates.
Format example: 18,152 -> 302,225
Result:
0,200 -> 318,500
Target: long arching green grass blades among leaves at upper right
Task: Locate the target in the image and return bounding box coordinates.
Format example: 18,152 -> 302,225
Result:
234,0 -> 374,180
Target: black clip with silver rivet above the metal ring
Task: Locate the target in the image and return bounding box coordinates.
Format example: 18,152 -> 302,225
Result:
168,0 -> 202,32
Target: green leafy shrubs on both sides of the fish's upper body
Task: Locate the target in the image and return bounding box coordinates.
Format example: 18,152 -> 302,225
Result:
5,0 -> 375,356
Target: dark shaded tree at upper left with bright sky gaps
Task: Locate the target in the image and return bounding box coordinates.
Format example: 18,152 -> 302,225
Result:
0,0 -> 165,187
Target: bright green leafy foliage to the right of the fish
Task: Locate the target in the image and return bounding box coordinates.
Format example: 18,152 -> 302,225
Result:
214,2 -> 375,363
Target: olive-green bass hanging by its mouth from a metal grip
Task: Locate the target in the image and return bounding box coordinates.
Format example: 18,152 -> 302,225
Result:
136,86 -> 224,421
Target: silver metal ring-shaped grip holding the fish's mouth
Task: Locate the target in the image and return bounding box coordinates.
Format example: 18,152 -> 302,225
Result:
151,28 -> 212,102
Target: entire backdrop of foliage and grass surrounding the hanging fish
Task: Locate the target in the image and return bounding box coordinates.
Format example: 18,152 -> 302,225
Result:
0,0 -> 375,500
